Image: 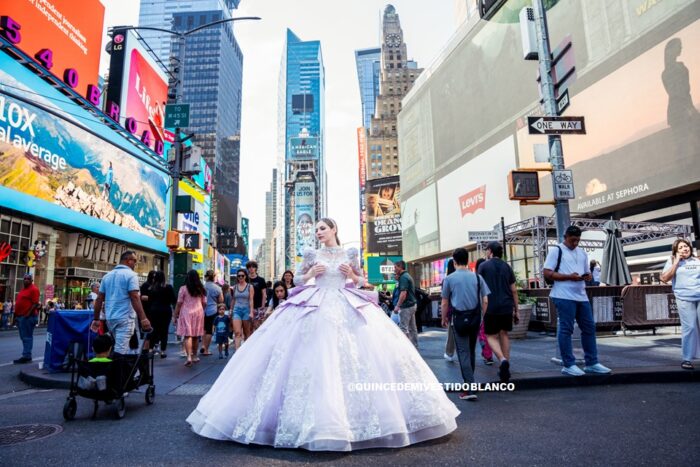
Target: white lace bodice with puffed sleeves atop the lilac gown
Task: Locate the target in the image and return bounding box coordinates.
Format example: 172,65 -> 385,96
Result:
295,247 -> 363,289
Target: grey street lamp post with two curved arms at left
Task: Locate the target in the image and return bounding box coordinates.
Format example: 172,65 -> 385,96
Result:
116,16 -> 261,285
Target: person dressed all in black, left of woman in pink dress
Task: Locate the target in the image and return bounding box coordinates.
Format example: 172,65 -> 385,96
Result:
141,271 -> 177,358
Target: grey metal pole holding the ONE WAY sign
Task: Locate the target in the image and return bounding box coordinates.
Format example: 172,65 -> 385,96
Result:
532,0 -> 571,242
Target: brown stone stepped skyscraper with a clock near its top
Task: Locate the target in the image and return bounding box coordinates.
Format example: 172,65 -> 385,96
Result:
367,5 -> 423,180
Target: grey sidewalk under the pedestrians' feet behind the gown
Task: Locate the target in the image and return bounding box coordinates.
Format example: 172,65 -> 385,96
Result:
19,328 -> 700,395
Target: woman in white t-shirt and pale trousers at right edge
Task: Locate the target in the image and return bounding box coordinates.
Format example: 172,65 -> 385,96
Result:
661,238 -> 700,370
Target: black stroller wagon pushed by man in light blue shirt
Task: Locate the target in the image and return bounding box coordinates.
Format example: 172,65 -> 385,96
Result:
63,332 -> 156,420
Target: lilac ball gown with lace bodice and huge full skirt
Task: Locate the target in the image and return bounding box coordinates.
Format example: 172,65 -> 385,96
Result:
187,248 -> 459,451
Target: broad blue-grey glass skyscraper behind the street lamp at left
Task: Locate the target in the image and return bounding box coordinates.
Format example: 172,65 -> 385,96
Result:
139,0 -> 243,253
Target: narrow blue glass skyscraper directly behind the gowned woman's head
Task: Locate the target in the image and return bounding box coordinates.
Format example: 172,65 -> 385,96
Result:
278,29 -> 327,269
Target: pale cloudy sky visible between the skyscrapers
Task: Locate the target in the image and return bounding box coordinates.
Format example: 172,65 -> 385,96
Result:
102,0 -> 455,254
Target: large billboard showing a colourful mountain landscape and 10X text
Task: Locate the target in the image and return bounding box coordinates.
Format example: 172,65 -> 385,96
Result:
0,52 -> 170,251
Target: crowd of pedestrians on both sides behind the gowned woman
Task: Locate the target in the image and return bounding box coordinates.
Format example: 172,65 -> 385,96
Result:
8,226 -> 700,380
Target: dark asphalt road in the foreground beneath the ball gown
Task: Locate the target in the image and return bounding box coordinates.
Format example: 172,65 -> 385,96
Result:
0,383 -> 700,467
